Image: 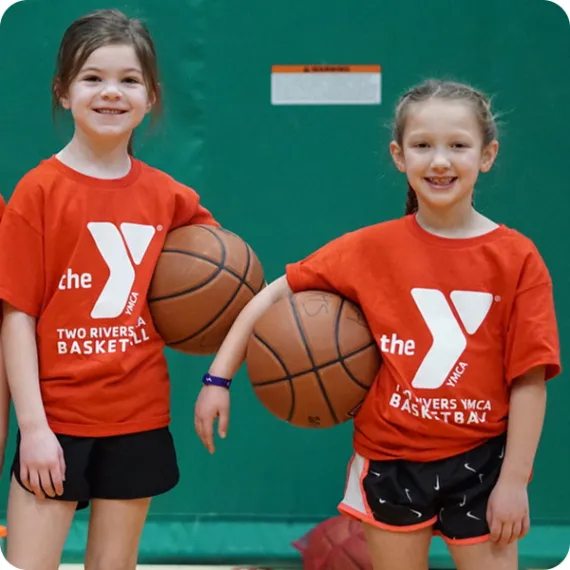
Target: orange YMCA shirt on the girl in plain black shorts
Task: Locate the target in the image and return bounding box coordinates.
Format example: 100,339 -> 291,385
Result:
0,157 -> 218,437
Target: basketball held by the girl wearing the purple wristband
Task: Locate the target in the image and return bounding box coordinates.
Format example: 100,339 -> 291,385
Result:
246,291 -> 381,428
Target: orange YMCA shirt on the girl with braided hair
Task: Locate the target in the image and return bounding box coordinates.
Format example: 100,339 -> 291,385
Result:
287,215 -> 561,461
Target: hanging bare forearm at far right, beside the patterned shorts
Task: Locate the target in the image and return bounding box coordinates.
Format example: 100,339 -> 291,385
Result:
501,367 -> 546,483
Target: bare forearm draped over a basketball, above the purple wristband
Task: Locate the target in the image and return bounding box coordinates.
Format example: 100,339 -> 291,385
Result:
209,276 -> 291,378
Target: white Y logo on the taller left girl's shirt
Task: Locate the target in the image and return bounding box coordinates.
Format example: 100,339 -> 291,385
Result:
87,222 -> 155,319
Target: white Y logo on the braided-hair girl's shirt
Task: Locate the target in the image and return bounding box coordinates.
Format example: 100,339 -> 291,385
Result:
412,289 -> 493,390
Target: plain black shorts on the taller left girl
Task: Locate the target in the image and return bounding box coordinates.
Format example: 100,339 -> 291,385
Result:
12,428 -> 180,509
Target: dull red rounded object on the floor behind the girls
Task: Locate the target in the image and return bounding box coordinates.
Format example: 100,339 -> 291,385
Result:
293,516 -> 372,570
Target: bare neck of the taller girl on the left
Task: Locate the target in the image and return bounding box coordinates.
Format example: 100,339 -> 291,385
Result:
57,130 -> 131,178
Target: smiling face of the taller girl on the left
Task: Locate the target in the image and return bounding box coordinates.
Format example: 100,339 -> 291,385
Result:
60,44 -> 152,146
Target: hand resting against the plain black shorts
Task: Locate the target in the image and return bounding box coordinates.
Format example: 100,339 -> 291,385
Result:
20,427 -> 65,499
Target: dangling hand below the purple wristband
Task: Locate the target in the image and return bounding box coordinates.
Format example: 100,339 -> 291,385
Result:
194,386 -> 230,453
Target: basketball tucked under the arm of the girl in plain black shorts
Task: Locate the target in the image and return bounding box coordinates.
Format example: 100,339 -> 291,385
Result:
148,225 -> 265,355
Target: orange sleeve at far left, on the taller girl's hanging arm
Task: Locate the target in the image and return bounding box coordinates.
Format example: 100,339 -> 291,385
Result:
0,182 -> 45,317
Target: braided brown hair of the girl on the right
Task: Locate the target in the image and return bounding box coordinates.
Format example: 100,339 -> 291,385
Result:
392,79 -> 498,215
